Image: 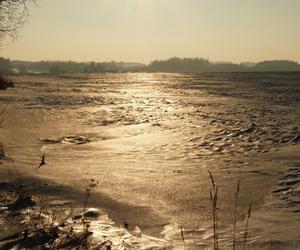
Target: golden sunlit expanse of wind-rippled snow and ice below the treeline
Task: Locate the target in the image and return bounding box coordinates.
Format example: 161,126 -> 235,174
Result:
0,73 -> 300,249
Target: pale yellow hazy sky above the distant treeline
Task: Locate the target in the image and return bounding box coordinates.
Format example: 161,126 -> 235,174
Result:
0,0 -> 300,62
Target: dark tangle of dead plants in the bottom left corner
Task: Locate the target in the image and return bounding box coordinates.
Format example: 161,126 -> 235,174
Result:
0,177 -> 98,249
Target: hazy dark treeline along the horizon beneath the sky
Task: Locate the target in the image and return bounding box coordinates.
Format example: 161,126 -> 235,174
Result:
0,57 -> 300,75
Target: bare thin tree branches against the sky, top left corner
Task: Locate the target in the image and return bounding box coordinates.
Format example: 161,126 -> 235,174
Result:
0,0 -> 34,40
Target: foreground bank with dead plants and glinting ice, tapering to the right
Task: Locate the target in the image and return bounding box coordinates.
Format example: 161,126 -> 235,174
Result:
0,175 -> 172,249
